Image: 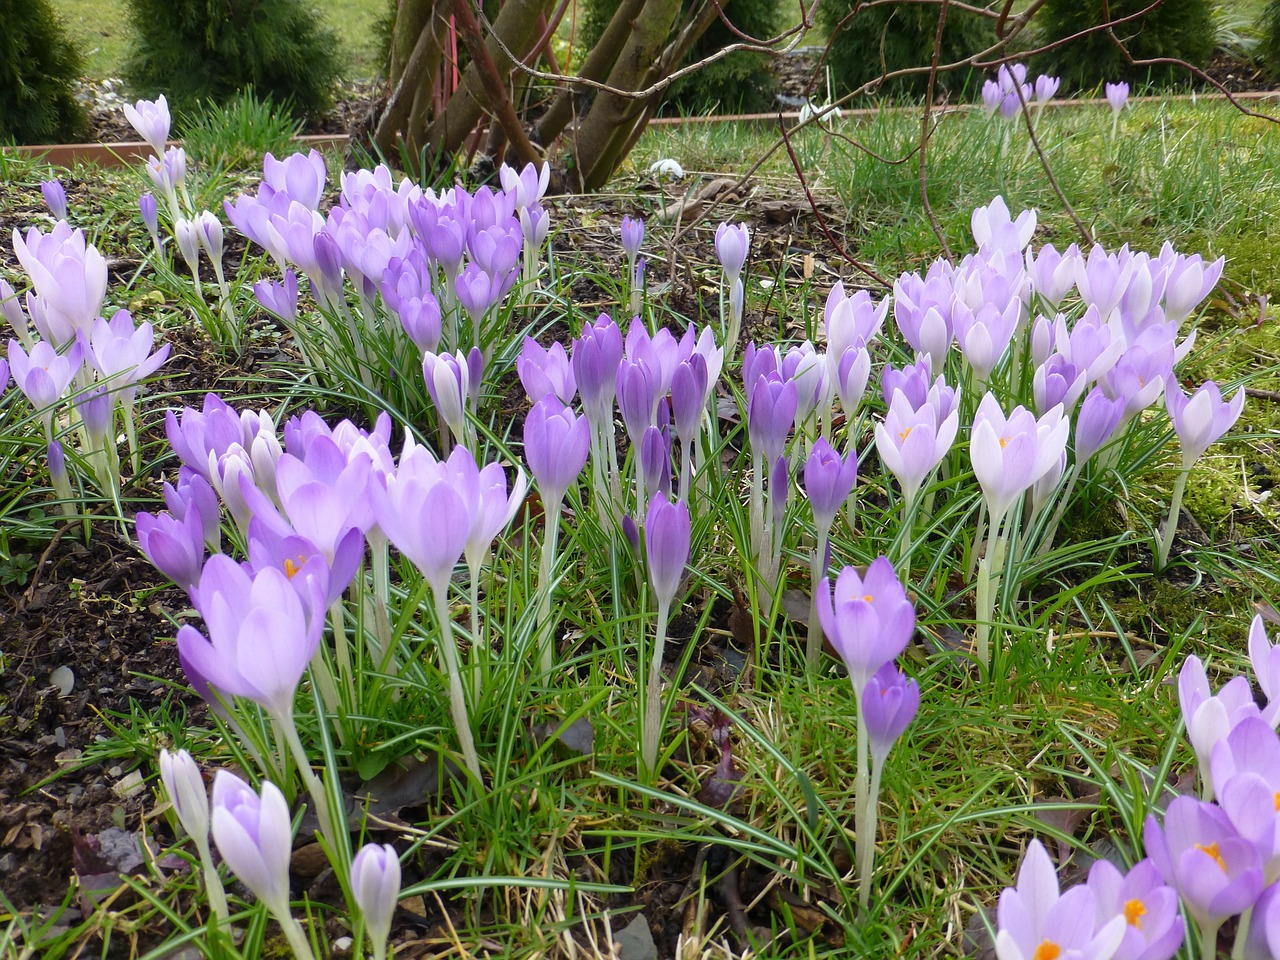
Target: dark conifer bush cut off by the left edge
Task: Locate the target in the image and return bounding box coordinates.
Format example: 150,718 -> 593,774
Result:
0,0 -> 84,143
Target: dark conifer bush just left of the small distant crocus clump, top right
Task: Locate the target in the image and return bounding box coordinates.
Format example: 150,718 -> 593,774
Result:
819,0 -> 996,96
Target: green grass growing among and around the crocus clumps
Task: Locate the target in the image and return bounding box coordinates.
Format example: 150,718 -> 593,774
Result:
0,97 -> 1280,957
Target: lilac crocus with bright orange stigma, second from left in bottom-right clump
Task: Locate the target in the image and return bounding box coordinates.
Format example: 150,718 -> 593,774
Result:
1087,860 -> 1185,960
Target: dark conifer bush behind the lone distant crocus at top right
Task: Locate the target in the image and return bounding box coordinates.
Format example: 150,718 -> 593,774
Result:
1033,0 -> 1216,90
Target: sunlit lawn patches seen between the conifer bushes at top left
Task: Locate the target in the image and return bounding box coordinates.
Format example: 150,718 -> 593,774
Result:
52,0 -> 388,79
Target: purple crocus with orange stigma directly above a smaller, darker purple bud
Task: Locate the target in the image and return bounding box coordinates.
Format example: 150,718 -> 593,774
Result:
815,557 -> 915,691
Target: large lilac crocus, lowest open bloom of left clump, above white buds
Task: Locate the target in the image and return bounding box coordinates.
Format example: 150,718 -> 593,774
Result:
178,554 -> 324,722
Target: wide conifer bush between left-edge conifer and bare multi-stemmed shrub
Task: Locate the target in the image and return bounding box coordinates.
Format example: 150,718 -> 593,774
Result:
124,0 -> 342,124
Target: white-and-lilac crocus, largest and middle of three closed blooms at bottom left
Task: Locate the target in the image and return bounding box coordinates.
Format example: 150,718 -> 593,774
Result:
211,771 -> 293,916
